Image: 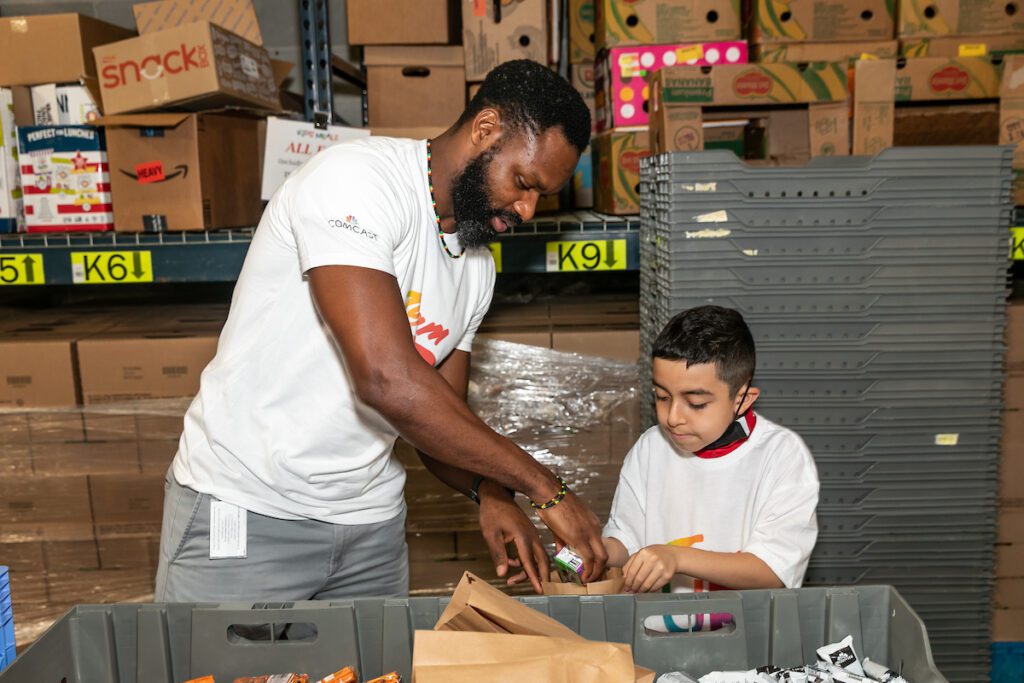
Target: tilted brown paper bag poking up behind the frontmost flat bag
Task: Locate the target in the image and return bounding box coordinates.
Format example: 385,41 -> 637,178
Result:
430,571 -> 654,683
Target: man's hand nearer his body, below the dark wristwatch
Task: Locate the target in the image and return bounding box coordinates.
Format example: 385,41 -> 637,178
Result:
479,481 -> 550,594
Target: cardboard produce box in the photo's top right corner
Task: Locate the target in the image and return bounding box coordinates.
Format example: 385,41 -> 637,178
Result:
898,0 -> 1024,38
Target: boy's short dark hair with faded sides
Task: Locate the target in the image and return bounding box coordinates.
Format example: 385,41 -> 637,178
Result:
651,306 -> 757,396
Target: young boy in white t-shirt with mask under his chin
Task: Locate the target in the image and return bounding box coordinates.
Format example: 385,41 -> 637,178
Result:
604,306 -> 818,610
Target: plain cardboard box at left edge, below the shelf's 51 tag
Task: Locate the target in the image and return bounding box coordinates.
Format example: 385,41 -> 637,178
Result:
0,333 -> 78,408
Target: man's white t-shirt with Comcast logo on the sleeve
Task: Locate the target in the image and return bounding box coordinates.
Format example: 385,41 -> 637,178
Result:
172,137 -> 495,524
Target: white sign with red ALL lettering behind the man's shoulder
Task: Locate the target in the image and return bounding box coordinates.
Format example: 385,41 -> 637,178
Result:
260,116 -> 372,201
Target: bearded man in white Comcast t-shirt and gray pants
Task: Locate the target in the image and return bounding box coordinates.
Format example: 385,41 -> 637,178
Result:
156,60 -> 606,602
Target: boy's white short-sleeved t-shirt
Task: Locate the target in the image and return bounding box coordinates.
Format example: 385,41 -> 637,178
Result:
604,415 -> 818,593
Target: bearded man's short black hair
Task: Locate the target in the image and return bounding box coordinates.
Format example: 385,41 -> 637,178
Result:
457,59 -> 590,154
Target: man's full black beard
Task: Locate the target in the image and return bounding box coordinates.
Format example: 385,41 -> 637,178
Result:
452,150 -> 522,249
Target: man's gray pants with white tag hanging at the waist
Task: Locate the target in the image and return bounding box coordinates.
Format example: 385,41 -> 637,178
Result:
156,471 -> 409,602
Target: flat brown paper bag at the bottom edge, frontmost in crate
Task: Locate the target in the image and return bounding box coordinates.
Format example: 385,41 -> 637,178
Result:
413,631 -> 635,683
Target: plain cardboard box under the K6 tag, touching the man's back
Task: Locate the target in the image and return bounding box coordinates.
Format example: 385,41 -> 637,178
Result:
77,331 -> 217,405
